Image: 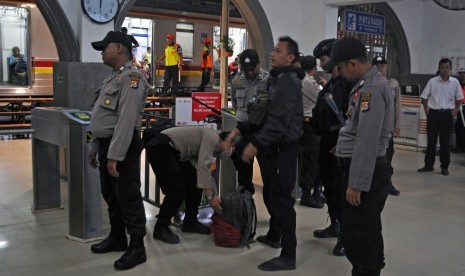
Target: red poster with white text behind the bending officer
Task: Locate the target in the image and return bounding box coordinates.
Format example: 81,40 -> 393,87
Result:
192,92 -> 221,121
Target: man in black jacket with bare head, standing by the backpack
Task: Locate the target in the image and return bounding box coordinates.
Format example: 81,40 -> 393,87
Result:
241,36 -> 305,271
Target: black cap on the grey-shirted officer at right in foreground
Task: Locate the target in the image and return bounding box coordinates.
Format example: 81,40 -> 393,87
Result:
330,37 -> 367,65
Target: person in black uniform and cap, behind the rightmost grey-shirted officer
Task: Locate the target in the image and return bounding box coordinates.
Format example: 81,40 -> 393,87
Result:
312,38 -> 354,256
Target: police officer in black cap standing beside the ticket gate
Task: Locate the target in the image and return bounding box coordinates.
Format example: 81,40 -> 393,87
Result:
88,31 -> 149,270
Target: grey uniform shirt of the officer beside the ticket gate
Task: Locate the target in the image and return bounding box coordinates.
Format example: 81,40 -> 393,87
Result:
91,61 -> 149,161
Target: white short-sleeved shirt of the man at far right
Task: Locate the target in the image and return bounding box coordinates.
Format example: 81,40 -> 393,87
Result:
421,76 -> 463,109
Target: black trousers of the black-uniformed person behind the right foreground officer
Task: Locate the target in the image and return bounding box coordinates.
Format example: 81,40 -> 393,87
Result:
318,130 -> 342,215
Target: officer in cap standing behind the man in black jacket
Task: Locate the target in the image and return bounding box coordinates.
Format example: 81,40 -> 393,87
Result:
229,49 -> 270,194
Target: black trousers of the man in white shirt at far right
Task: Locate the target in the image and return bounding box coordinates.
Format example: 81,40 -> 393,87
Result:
425,109 -> 452,169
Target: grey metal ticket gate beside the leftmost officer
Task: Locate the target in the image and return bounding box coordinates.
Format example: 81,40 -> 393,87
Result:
31,107 -> 102,242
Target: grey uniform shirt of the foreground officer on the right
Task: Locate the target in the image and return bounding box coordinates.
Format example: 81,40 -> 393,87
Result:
336,66 -> 394,191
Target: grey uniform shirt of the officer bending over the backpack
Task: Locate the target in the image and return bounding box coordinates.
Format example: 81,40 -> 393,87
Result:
161,126 -> 220,189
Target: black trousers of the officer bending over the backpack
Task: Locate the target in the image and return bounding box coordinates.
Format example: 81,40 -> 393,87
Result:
146,137 -> 202,226
